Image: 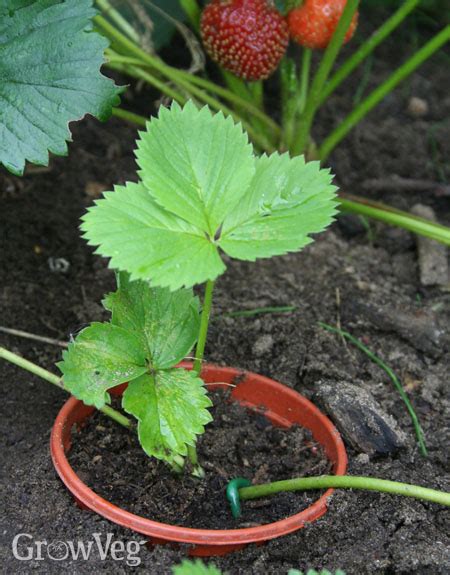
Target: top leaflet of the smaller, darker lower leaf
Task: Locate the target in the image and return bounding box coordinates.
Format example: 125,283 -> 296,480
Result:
104,281 -> 200,369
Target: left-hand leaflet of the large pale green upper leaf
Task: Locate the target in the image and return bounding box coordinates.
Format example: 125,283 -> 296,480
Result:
81,183 -> 225,290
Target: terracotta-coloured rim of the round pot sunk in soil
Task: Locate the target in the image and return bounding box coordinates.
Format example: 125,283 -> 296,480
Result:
50,362 -> 347,546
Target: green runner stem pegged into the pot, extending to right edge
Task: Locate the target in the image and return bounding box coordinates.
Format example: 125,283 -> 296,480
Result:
239,475 -> 450,506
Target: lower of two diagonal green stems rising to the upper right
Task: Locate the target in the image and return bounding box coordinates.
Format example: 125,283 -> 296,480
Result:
319,26 -> 450,161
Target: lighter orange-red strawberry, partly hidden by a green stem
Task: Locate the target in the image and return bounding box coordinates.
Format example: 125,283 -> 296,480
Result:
288,0 -> 358,50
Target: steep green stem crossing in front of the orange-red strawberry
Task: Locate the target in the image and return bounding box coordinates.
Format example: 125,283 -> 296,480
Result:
292,0 -> 359,155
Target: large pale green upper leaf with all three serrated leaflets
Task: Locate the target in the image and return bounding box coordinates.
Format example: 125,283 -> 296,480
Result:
82,103 -> 336,290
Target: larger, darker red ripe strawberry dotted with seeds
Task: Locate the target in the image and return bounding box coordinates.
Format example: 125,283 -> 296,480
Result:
201,0 -> 289,81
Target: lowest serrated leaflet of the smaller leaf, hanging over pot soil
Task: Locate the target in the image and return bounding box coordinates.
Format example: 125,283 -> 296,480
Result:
122,369 -> 212,462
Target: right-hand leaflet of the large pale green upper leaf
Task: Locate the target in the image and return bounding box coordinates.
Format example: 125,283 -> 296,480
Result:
218,154 -> 337,261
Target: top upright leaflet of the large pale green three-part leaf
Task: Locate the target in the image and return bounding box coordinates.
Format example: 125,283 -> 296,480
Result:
136,102 -> 254,239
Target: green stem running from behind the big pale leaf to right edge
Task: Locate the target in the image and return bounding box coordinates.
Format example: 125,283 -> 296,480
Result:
338,194 -> 450,246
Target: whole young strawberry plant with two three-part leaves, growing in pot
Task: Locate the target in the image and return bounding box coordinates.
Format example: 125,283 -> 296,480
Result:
59,103 -> 336,475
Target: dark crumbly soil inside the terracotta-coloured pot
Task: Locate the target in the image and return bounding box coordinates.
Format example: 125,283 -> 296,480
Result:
69,391 -> 331,529
